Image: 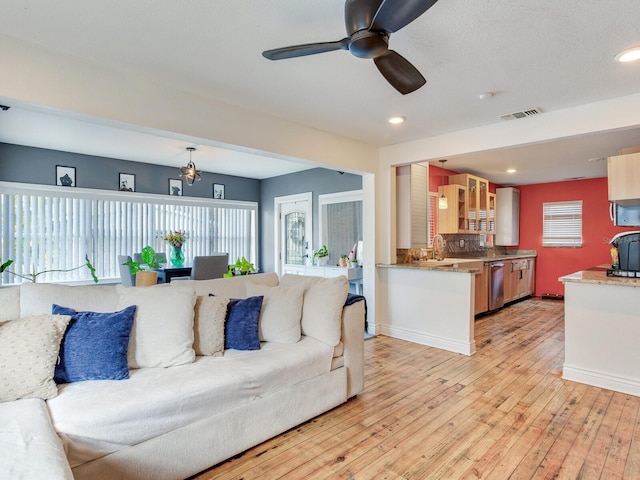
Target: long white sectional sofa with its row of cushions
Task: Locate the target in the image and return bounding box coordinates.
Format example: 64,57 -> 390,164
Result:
0,273 -> 365,480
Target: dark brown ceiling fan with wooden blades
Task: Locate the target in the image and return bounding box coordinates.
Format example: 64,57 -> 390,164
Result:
262,0 -> 438,95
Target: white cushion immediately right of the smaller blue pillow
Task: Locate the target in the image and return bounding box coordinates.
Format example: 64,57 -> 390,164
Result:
247,283 -> 304,343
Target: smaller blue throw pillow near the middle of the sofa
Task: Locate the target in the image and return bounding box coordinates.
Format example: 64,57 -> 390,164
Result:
224,295 -> 264,350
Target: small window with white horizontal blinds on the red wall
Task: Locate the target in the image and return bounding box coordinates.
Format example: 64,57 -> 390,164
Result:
542,200 -> 582,247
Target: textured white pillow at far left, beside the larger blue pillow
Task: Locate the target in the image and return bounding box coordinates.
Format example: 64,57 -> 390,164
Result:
0,314 -> 71,402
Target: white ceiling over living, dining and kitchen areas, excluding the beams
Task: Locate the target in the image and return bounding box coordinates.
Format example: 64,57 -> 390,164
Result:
0,0 -> 640,184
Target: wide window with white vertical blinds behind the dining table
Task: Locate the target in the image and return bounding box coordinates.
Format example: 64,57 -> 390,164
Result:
0,182 -> 258,285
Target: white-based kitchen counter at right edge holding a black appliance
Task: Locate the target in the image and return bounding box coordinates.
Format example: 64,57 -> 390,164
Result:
559,266 -> 640,396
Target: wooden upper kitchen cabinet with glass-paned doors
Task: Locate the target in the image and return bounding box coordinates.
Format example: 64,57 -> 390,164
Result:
449,173 -> 496,234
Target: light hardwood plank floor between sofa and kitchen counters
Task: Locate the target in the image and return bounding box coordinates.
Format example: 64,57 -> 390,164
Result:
196,299 -> 640,480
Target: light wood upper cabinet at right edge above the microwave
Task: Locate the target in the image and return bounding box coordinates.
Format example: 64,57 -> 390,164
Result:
607,153 -> 640,206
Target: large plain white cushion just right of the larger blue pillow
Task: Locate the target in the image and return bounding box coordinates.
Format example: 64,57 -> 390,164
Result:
116,285 -> 196,368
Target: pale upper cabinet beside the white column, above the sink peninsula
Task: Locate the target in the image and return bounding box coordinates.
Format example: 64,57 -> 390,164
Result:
396,163 -> 429,248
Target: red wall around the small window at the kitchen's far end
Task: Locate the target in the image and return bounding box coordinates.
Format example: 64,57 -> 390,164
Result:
516,177 -> 638,296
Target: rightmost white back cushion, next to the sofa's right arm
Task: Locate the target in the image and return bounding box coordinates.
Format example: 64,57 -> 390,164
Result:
280,275 -> 349,347
